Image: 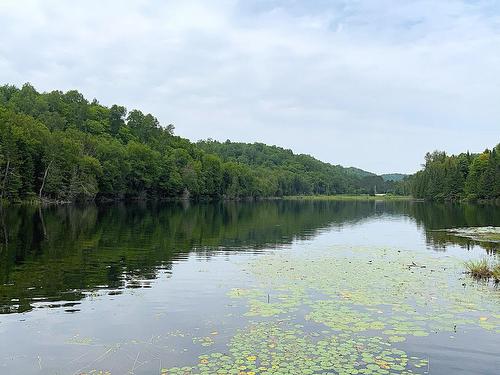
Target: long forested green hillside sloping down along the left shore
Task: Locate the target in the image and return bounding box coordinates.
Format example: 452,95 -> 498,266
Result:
0,83 -> 397,202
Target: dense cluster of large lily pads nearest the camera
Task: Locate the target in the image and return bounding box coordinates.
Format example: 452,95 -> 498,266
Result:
163,321 -> 428,375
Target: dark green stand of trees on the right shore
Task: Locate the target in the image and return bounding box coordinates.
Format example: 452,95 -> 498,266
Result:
408,144 -> 500,201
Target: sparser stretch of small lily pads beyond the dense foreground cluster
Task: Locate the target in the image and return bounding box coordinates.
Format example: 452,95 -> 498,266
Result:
230,249 -> 500,336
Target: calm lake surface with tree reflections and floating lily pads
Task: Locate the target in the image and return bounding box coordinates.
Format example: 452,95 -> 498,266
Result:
0,201 -> 500,375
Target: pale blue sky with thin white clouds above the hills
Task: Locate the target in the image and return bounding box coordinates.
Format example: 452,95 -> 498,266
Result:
0,0 -> 500,173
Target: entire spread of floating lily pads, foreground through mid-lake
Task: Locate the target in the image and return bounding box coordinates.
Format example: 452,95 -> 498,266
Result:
162,248 -> 500,375
